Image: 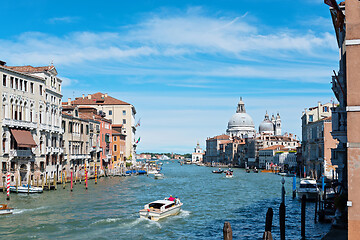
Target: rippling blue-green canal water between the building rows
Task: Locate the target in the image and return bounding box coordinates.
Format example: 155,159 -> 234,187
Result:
0,162 -> 330,240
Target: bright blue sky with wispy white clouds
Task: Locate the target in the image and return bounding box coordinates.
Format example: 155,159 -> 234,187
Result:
0,0 -> 338,153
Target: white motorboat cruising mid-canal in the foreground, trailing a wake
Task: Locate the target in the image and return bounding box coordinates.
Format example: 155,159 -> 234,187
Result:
139,197 -> 183,221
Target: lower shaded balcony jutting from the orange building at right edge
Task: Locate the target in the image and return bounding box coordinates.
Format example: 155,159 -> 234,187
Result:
331,106 -> 347,143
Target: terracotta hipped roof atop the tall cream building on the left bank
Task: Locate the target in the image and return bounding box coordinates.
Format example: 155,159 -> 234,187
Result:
71,92 -> 130,105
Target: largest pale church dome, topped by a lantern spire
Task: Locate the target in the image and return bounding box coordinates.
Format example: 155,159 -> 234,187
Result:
226,97 -> 255,138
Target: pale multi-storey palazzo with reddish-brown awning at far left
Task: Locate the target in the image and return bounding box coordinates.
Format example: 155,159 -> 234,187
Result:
0,61 -> 63,184
